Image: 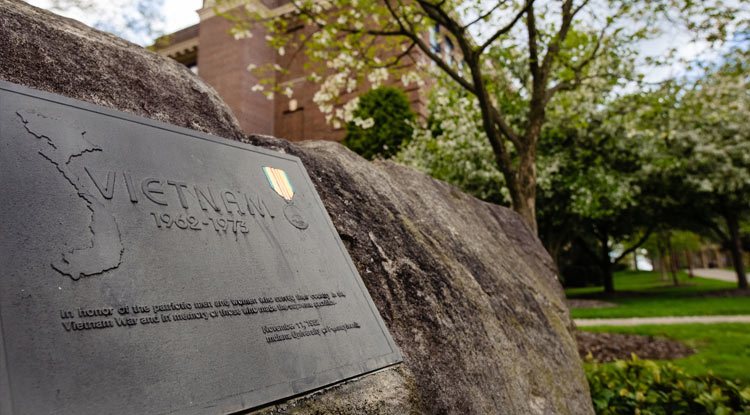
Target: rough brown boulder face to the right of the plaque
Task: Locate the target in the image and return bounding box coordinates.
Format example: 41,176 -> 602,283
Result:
248,136 -> 590,414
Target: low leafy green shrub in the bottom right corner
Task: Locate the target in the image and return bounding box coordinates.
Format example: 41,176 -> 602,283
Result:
586,355 -> 750,415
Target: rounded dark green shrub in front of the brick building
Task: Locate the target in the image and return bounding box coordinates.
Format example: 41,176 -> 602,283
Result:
343,87 -> 414,160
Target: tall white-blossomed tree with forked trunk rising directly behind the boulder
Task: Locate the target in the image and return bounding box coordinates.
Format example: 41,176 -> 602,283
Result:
223,0 -> 660,234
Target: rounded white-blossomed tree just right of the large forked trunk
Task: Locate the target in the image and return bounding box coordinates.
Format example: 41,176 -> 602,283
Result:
538,96 -> 669,293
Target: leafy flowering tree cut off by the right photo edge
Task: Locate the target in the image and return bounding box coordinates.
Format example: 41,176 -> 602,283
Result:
663,49 -> 750,289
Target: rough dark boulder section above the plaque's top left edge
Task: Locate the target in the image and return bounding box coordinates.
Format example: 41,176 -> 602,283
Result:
0,0 -> 242,139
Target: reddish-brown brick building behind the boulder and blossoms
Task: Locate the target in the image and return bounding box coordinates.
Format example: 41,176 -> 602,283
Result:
154,0 -> 439,141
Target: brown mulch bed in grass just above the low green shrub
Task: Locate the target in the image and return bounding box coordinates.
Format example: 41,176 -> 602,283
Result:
576,331 -> 695,363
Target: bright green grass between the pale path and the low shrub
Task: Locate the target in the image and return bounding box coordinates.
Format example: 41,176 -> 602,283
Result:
585,323 -> 750,385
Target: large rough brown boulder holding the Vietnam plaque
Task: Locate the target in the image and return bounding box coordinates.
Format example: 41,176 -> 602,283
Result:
0,0 -> 593,414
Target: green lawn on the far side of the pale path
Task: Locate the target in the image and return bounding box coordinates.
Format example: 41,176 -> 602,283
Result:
565,271 -> 750,318
